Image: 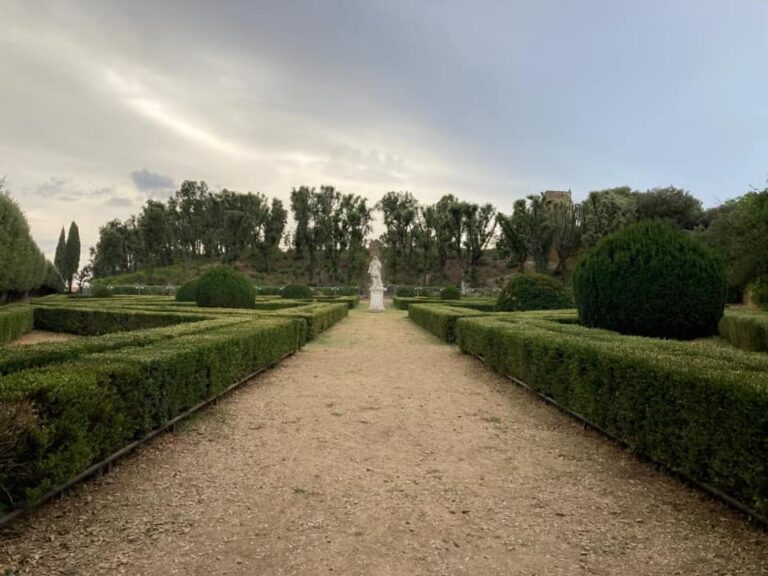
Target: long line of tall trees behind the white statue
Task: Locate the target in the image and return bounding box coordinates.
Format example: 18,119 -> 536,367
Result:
88,181 -> 768,296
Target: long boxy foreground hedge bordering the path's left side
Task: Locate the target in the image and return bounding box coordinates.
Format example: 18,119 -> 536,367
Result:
0,318 -> 306,509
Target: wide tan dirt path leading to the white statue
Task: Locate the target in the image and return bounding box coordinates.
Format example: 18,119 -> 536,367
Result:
0,311 -> 768,576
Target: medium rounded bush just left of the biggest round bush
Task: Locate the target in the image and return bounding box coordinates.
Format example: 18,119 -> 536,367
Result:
496,273 -> 573,312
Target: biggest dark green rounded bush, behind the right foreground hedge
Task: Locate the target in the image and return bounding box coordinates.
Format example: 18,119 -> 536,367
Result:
573,221 -> 726,340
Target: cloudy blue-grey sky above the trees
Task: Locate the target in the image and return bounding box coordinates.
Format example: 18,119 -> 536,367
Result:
0,0 -> 768,263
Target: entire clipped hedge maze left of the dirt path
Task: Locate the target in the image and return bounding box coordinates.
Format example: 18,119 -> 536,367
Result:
0,296 -> 356,513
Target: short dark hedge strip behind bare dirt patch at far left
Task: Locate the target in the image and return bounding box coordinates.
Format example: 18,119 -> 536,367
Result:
34,306 -> 205,336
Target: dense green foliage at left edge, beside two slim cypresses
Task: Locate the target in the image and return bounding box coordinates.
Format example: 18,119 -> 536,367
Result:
0,189 -> 47,303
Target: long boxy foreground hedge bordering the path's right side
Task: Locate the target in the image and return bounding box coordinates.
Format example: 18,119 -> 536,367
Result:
456,313 -> 768,515
